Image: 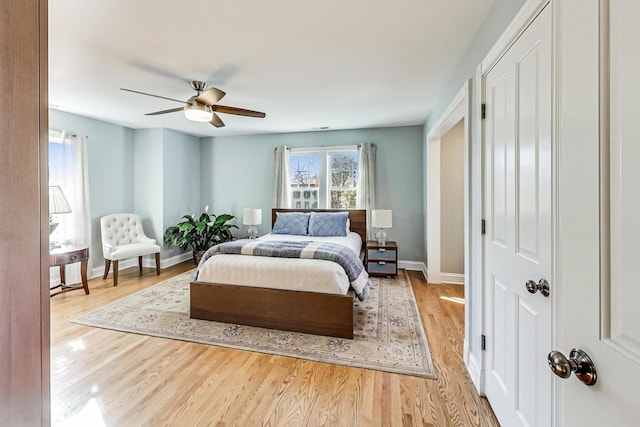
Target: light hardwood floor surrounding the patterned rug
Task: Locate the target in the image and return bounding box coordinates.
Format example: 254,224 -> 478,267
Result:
51,261 -> 498,427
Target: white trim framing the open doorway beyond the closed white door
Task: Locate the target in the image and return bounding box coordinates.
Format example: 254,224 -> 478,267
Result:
425,80 -> 471,370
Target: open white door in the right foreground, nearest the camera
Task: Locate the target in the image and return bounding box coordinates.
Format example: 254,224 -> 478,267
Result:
555,0 -> 640,426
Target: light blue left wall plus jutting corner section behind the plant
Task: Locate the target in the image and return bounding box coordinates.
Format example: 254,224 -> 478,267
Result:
49,110 -> 204,268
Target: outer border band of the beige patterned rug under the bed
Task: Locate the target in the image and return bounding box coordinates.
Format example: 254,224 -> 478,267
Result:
71,269 -> 437,379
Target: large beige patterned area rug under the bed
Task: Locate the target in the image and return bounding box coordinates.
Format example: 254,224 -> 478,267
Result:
73,270 -> 436,378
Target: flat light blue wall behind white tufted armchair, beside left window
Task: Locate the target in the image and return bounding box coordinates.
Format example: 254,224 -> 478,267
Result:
49,110 -> 134,267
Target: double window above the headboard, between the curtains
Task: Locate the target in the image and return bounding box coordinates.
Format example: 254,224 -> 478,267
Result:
289,146 -> 359,209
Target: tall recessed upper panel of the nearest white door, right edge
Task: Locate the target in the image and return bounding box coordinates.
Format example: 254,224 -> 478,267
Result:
601,2 -> 640,362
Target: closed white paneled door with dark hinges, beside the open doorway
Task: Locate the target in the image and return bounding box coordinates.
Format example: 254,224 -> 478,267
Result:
484,6 -> 553,427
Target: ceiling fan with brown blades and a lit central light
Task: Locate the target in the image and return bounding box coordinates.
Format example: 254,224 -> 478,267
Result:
120,80 -> 266,128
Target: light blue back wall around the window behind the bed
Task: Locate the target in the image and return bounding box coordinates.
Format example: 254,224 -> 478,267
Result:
200,126 -> 424,261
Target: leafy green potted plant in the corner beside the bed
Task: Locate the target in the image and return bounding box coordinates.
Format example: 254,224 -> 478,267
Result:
164,206 -> 238,265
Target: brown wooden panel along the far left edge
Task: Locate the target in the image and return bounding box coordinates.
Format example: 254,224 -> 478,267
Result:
0,0 -> 50,426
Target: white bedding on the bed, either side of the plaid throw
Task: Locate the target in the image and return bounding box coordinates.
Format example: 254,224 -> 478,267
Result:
198,232 -> 362,295
